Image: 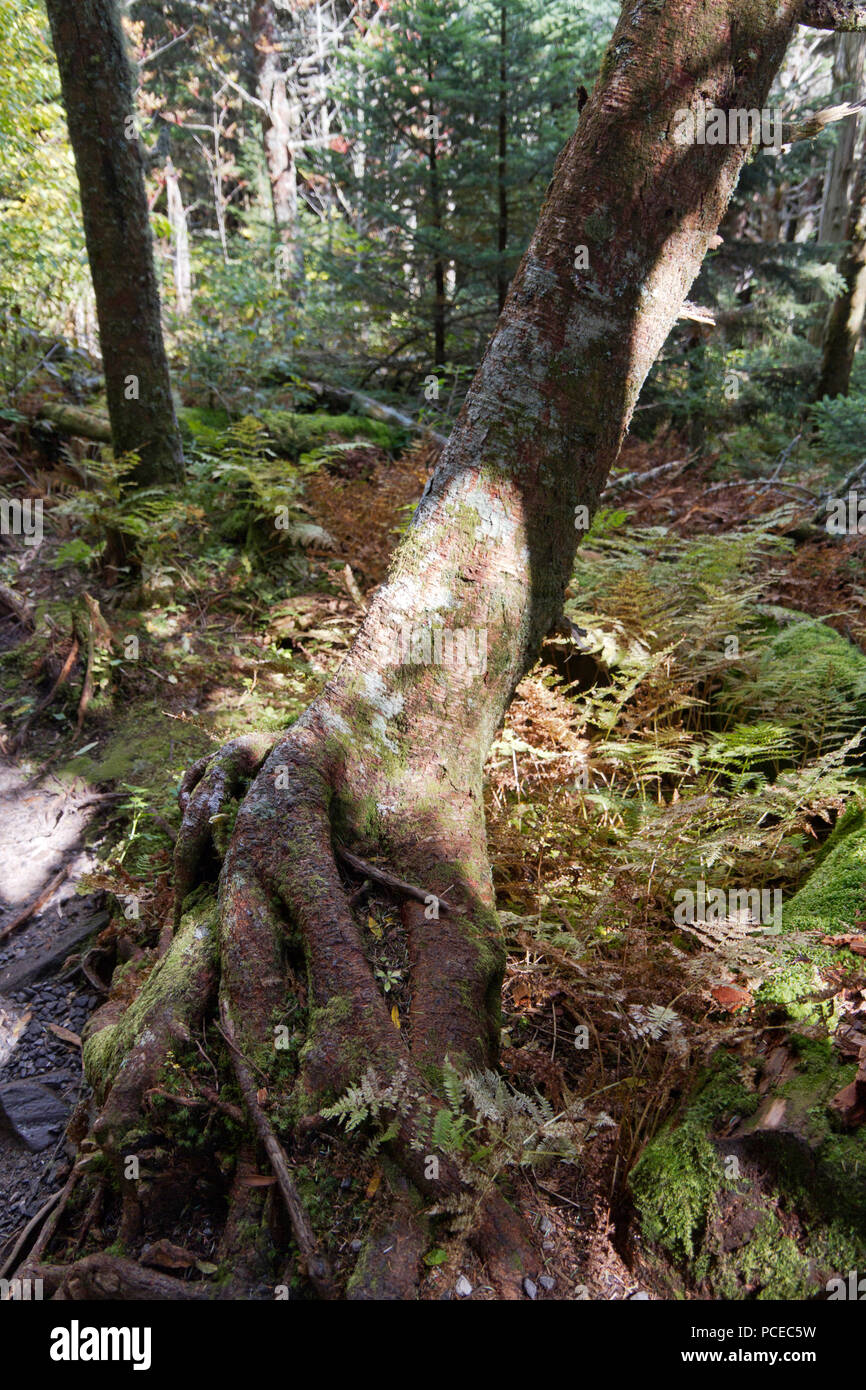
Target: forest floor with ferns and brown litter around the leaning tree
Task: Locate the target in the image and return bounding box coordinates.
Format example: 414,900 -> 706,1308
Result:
0,405 -> 866,1298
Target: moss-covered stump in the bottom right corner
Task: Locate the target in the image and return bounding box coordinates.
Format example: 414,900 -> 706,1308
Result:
630,1034 -> 866,1300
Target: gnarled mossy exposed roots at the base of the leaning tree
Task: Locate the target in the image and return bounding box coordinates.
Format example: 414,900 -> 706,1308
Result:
51,720 -> 538,1300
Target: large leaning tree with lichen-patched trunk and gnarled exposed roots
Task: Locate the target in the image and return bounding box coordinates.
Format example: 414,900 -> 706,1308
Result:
74,0 -> 845,1297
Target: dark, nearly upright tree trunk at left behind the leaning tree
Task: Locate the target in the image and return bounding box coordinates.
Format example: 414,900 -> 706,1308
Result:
46,0 -> 183,484
